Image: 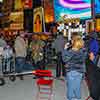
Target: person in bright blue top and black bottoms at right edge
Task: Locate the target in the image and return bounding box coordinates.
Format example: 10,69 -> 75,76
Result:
86,32 -> 100,100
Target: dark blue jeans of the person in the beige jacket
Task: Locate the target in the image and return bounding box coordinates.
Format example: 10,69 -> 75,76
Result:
15,57 -> 25,73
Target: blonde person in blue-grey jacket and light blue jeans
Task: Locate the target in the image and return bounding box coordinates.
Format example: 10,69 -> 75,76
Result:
62,35 -> 87,100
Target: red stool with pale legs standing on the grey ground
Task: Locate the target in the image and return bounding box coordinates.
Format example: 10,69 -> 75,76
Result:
33,70 -> 53,100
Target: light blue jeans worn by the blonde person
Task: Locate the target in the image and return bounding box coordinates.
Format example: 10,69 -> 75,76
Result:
66,71 -> 83,100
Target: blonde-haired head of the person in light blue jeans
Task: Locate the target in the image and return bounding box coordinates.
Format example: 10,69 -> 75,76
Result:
72,35 -> 84,50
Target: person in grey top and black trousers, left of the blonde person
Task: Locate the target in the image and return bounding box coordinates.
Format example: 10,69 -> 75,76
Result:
52,32 -> 66,77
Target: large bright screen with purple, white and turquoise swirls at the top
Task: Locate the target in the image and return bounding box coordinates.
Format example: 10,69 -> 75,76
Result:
54,0 -> 91,21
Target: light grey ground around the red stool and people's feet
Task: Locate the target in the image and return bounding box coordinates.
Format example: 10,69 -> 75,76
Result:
0,76 -> 88,100
